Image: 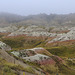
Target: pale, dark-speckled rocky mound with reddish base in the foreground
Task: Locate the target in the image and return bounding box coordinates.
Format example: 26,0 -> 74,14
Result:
11,47 -> 63,65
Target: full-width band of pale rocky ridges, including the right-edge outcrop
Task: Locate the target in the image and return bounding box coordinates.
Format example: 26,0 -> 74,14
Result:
0,25 -> 75,43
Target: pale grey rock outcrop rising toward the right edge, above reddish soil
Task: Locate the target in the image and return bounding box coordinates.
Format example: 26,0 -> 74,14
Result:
48,27 -> 75,43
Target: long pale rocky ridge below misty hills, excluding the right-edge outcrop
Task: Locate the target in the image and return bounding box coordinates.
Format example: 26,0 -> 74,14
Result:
0,25 -> 69,37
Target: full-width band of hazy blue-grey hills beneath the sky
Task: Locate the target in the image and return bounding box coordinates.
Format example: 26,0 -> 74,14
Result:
0,13 -> 75,26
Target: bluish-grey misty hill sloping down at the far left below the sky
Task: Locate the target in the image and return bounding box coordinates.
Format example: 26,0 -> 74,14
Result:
0,13 -> 24,26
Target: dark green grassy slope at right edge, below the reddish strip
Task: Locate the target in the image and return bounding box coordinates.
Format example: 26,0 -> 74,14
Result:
46,45 -> 75,58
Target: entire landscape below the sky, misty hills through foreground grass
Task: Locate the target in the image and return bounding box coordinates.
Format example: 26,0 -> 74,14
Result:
0,14 -> 75,75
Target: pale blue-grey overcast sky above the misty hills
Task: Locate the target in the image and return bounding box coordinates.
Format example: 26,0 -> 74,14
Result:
0,0 -> 75,15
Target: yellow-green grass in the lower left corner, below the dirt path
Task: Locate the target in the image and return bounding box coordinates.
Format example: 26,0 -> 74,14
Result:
0,58 -> 35,75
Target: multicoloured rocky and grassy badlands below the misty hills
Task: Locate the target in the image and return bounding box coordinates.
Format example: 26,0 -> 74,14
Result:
0,25 -> 75,75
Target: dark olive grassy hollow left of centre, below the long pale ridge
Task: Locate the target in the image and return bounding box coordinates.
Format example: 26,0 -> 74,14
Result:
1,37 -> 43,49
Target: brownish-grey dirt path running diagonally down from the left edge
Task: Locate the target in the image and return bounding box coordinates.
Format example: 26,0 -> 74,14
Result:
0,50 -> 44,75
